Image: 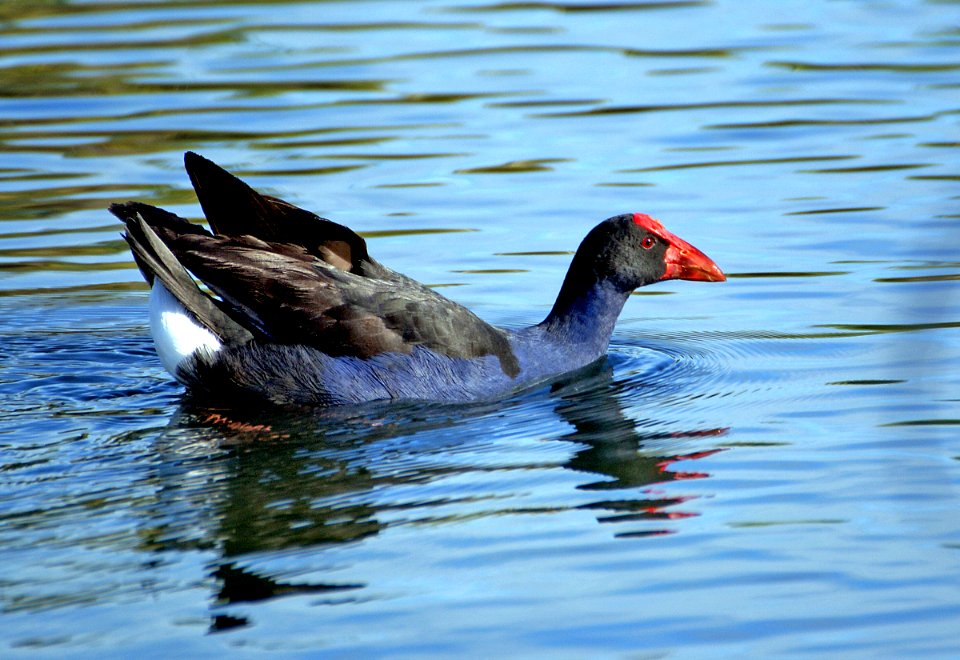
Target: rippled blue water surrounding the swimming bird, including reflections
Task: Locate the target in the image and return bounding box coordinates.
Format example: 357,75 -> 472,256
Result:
0,0 -> 960,657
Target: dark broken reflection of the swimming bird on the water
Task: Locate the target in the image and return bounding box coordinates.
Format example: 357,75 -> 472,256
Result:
144,361 -> 722,631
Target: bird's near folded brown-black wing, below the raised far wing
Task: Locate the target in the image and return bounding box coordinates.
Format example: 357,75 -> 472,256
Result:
157,227 -> 517,373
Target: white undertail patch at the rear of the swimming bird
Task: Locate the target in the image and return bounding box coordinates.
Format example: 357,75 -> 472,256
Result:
150,280 -> 223,378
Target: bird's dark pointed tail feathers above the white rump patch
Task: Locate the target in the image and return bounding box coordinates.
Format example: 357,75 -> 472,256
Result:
110,202 -> 253,344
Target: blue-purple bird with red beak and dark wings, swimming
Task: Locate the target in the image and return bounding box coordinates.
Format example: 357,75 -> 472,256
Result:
110,152 -> 726,406
